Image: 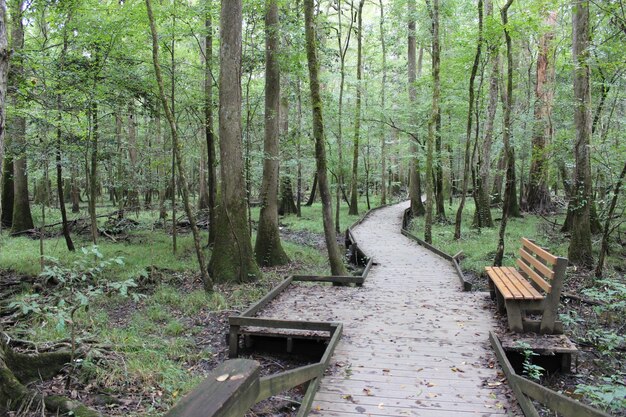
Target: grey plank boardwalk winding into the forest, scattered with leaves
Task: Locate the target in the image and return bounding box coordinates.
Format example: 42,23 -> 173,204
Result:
262,203 -> 516,417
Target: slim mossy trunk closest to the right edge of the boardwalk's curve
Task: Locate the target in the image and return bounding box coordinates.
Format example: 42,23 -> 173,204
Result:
424,0 -> 441,243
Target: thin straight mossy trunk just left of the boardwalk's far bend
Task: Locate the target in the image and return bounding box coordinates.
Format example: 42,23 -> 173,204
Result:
349,0 -> 365,215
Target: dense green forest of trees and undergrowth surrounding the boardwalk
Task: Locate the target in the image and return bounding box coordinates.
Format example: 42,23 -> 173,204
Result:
0,0 -> 626,409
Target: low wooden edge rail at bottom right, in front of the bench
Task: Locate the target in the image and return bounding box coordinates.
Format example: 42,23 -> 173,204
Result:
489,332 -> 609,417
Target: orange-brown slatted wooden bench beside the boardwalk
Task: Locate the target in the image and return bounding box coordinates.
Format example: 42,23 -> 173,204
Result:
485,238 -> 568,334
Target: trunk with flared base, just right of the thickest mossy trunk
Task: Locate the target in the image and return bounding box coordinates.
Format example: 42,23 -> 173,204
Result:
254,0 -> 293,266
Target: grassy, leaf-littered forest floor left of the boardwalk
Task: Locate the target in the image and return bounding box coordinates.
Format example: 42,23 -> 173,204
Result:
0,200 -> 358,416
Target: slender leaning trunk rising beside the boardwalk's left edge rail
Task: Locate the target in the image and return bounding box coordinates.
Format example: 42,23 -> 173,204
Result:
304,0 -> 347,275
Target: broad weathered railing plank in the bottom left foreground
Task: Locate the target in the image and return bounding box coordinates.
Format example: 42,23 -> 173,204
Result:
165,359 -> 260,417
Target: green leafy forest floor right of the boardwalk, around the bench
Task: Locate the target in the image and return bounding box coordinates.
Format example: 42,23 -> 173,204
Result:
411,201 -> 626,416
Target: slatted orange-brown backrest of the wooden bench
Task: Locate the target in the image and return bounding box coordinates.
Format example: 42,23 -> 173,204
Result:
517,238 -> 567,294
